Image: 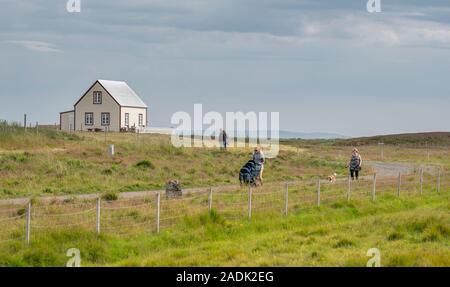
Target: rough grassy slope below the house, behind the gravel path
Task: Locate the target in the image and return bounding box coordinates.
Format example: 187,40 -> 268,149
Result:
0,129 -> 345,198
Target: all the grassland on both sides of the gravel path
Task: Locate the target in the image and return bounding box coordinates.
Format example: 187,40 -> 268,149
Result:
0,123 -> 450,266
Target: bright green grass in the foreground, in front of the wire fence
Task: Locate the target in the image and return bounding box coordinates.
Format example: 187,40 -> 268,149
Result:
0,193 -> 450,266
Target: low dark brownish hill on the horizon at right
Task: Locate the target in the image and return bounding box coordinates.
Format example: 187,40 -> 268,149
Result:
334,132 -> 450,146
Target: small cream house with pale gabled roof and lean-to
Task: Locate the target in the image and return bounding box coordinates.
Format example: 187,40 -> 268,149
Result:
60,80 -> 148,131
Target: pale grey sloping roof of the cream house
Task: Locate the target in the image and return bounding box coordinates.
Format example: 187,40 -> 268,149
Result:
97,80 -> 147,108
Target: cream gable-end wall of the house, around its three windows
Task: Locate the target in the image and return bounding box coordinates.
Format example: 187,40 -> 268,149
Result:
75,82 -> 121,131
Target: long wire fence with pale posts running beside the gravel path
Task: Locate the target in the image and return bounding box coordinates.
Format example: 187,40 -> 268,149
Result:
0,168 -> 450,244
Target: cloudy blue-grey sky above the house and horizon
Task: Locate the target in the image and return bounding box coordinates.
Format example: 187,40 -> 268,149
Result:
0,0 -> 450,136
